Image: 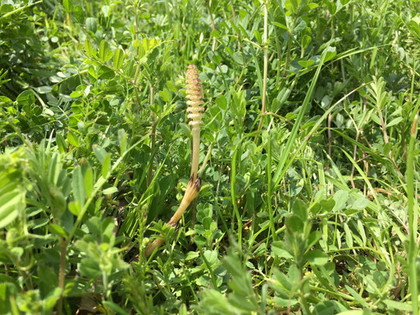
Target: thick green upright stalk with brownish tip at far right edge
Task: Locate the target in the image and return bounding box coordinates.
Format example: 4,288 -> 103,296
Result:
405,109 -> 420,315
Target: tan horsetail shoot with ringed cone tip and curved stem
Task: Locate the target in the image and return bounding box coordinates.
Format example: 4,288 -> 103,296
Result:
144,65 -> 204,257
